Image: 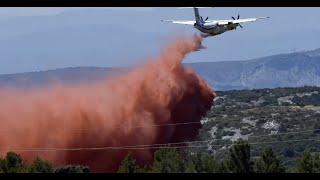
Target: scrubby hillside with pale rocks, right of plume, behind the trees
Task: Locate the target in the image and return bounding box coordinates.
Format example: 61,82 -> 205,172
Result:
195,86 -> 320,169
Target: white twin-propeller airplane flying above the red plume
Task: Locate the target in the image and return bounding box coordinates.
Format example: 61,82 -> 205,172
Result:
161,7 -> 270,37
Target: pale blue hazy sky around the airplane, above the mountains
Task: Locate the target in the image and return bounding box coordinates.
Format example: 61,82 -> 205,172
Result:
0,7 -> 320,74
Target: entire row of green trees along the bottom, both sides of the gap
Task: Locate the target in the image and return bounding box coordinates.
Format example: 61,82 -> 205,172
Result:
0,140 -> 320,173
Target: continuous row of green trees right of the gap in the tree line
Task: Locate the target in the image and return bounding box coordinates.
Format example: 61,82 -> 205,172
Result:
118,140 -> 320,173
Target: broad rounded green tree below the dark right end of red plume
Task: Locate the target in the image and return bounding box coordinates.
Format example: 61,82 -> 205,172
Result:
151,146 -> 187,173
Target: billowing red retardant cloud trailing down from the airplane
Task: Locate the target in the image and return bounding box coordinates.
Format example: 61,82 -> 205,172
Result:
0,35 -> 216,172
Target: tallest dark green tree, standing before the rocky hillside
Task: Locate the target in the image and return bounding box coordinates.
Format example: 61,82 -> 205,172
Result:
227,140 -> 253,173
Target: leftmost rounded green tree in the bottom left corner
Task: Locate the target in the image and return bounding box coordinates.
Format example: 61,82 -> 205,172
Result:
0,151 -> 27,173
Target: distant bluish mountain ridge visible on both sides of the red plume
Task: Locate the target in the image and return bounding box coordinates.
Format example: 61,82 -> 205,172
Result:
0,48 -> 320,90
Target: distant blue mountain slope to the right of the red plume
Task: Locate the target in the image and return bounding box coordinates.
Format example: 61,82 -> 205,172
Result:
189,49 -> 320,90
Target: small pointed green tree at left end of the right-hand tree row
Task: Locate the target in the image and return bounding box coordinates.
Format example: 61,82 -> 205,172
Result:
118,153 -> 144,173
